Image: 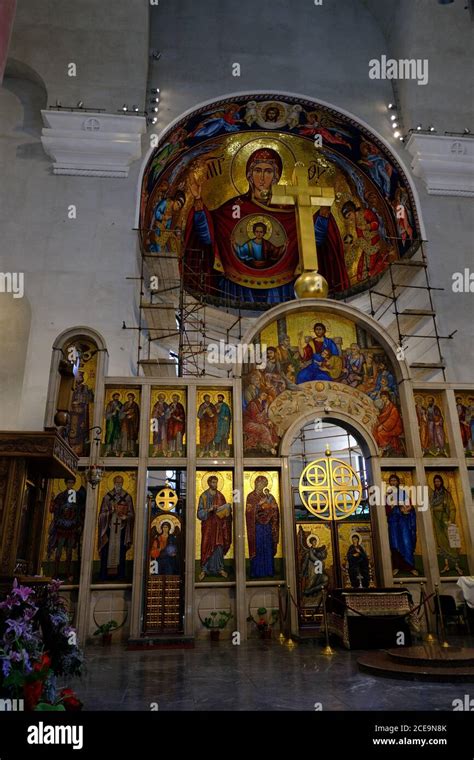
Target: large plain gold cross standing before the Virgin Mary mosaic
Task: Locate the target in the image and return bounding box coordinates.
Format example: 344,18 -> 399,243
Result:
270,161 -> 335,272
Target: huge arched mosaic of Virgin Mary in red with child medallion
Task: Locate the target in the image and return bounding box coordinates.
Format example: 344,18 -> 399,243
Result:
140,96 -> 419,309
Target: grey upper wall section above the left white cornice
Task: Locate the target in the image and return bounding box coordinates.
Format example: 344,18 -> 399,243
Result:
9,0 -> 149,113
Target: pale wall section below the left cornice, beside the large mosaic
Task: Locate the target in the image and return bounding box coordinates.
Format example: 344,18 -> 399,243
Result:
0,77 -> 143,429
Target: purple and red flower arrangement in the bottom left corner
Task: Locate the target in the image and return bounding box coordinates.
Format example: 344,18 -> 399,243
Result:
0,578 -> 83,710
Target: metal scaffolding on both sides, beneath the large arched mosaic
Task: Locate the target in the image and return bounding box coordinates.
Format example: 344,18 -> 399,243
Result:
128,232 -> 456,380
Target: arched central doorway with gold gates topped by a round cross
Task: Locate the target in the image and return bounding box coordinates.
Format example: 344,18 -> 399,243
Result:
288,418 -> 380,631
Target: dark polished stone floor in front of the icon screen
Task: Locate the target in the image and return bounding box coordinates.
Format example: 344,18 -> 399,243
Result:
70,641 -> 474,711
